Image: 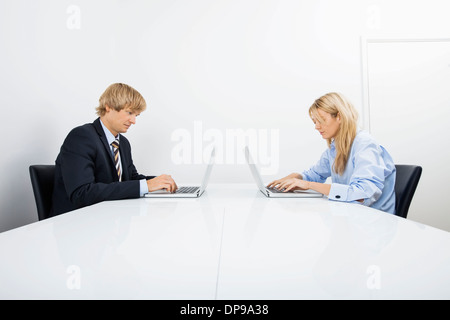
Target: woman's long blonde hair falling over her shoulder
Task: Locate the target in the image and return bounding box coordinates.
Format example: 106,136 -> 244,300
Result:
309,92 -> 358,175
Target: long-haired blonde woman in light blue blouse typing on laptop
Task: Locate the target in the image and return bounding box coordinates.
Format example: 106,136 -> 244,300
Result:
268,92 -> 396,214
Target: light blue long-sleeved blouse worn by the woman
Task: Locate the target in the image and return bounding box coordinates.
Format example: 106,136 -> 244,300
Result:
301,130 -> 396,213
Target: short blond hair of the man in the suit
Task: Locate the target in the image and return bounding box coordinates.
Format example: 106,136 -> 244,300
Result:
95,83 -> 147,117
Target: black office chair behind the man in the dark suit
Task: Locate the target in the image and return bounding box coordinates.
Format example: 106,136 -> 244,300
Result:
30,165 -> 55,220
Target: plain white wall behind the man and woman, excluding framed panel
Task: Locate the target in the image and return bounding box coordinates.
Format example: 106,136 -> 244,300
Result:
0,0 -> 450,231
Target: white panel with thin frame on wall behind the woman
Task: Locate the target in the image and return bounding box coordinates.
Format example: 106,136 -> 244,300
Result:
362,39 -> 450,231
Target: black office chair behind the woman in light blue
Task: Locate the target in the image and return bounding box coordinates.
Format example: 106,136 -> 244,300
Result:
395,164 -> 422,219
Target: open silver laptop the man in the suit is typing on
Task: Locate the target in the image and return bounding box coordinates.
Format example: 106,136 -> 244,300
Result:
144,148 -> 216,198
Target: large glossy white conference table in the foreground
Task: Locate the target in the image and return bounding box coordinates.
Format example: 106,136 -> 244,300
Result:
0,184 -> 450,300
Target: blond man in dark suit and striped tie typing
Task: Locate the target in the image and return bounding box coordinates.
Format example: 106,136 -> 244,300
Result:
50,83 -> 178,216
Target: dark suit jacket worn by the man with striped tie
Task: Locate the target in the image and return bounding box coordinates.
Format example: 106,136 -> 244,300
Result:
50,118 -> 154,216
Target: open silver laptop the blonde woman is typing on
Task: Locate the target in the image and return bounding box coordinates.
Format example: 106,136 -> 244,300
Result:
244,147 -> 323,198
